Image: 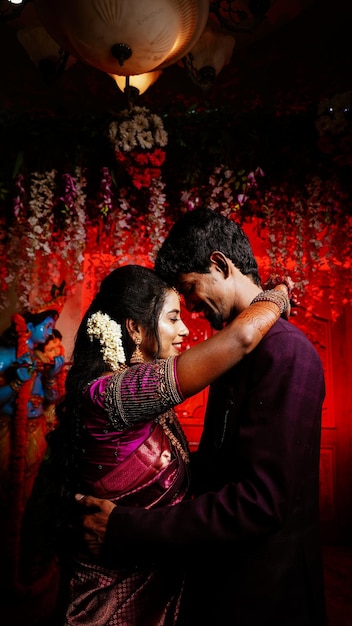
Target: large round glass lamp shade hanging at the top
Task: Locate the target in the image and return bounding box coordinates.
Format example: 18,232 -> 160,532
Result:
35,0 -> 209,76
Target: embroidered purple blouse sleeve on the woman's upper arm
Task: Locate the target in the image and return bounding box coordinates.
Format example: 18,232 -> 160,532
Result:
104,357 -> 184,430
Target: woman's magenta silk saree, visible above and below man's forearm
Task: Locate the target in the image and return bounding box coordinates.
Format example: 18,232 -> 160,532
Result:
65,424 -> 188,626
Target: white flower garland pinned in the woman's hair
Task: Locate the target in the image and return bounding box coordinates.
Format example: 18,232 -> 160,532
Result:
87,311 -> 126,372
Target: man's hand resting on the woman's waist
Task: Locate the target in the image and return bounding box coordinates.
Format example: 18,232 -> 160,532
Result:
75,493 -> 116,559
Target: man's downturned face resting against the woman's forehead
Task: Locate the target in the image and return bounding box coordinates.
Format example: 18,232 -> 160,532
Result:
177,264 -> 233,330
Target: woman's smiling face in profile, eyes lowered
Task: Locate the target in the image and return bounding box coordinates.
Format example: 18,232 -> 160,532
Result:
140,289 -> 189,361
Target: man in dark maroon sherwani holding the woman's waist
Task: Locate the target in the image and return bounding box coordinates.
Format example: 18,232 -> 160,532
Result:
76,209 -> 326,626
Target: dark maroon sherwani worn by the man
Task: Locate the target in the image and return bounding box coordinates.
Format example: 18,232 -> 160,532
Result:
104,319 -> 326,626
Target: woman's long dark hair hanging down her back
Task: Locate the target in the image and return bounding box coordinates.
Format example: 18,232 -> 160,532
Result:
39,265 -> 170,552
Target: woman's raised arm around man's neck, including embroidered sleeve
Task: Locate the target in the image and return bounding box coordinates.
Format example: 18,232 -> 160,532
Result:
101,285 -> 290,430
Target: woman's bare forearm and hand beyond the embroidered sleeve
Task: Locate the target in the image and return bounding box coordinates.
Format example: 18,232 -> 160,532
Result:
176,284 -> 290,398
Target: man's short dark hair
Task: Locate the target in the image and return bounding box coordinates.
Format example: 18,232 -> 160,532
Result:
155,208 -> 260,285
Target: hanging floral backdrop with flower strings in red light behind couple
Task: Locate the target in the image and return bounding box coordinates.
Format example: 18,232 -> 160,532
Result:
0,92 -> 352,319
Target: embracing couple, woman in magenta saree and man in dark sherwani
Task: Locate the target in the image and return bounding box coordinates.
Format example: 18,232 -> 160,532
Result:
44,209 -> 326,626
